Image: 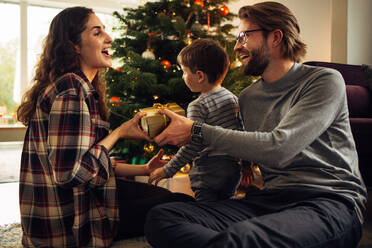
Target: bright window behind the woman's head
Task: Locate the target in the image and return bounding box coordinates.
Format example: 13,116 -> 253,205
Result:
0,0 -> 115,130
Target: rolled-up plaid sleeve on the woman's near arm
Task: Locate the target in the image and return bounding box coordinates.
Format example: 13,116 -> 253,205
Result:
48,94 -> 110,187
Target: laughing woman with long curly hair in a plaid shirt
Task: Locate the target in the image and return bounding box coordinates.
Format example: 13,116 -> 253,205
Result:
17,7 -> 190,247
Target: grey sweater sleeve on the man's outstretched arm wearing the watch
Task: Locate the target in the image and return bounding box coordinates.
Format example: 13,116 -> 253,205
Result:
202,70 -> 346,166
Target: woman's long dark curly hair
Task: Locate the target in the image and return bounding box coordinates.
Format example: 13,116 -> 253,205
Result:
17,7 -> 108,126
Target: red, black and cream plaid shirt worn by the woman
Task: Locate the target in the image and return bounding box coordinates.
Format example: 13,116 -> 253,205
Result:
19,73 -> 119,247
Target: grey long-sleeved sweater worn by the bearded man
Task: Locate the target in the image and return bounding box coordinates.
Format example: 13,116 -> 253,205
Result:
202,64 -> 367,223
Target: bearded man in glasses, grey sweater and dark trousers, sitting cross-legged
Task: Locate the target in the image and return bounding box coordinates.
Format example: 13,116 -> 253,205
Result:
145,2 -> 366,248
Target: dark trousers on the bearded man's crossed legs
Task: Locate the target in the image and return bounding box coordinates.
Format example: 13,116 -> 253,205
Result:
145,188 -> 361,248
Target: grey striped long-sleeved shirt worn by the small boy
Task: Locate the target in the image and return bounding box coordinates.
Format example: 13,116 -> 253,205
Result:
163,87 -> 243,177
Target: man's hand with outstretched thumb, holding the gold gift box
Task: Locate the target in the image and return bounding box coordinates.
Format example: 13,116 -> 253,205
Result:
154,109 -> 194,146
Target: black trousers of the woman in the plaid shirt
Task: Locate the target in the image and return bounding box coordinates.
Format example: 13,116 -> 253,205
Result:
115,179 -> 194,240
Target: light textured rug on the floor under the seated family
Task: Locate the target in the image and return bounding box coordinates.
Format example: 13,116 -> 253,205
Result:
0,223 -> 151,248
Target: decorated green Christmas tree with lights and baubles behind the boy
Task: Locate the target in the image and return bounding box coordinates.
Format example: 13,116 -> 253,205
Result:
106,0 -> 252,163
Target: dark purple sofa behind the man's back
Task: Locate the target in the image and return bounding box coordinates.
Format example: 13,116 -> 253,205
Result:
304,61 -> 372,187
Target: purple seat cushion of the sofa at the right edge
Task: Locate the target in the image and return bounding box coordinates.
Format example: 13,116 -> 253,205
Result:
346,85 -> 372,118
